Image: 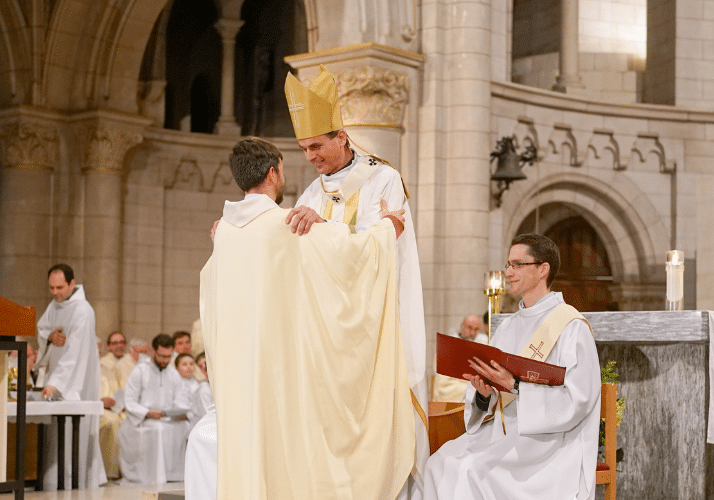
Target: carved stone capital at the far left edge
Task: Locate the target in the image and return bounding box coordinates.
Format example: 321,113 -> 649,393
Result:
0,120 -> 59,172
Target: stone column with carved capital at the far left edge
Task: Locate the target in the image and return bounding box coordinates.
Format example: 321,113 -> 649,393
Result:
0,115 -> 58,310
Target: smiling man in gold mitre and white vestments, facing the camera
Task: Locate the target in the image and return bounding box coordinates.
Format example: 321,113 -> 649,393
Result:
285,66 -> 429,500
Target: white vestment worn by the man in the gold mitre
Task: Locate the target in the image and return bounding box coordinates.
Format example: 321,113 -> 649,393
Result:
295,151 -> 429,500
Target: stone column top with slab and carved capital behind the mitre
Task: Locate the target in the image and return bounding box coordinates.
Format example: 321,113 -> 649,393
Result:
286,43 -> 423,176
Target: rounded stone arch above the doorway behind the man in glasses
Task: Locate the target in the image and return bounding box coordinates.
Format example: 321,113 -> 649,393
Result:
503,171 -> 669,283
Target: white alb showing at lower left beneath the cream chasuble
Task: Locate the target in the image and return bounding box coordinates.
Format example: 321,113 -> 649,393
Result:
184,408 -> 218,500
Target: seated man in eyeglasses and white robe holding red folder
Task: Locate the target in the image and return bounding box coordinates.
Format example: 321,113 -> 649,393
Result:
424,234 -> 600,500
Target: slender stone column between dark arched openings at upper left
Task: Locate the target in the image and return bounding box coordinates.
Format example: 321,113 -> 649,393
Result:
215,18 -> 243,136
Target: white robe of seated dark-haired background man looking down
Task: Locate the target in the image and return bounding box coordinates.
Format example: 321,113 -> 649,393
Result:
119,361 -> 189,484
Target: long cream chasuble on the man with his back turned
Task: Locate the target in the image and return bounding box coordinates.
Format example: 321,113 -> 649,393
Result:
201,195 -> 415,500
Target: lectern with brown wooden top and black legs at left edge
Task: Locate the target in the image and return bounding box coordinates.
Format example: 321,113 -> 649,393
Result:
0,297 -> 36,500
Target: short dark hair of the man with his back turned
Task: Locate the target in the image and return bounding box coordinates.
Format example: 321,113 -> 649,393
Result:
228,137 -> 283,192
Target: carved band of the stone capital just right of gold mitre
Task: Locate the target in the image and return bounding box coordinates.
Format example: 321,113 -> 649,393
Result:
335,66 -> 409,128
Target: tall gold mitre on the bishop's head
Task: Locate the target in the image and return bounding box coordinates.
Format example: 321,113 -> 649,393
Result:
285,64 -> 342,139
